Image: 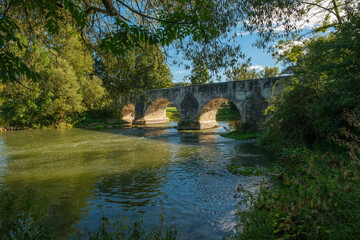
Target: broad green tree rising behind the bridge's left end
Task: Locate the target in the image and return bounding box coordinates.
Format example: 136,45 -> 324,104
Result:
98,44 -> 172,96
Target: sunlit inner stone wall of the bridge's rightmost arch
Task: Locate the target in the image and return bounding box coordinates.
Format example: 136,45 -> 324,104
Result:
199,98 -> 241,129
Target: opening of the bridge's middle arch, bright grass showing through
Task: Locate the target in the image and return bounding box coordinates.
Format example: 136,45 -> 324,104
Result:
144,98 -> 180,124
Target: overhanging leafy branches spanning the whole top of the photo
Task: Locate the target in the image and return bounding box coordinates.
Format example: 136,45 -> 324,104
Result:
0,0 -> 356,82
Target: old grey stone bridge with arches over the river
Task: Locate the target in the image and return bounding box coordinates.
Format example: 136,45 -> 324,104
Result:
119,77 -> 289,130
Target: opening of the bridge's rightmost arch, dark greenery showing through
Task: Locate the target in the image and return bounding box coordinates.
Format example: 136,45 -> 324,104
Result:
199,98 -> 241,128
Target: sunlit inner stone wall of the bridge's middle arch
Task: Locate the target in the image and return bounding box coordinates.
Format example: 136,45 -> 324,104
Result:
143,98 -> 178,124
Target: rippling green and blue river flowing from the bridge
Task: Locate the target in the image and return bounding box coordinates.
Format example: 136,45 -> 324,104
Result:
0,123 -> 272,240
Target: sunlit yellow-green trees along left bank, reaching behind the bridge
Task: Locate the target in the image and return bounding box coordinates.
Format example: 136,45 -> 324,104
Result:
0,13 -> 172,129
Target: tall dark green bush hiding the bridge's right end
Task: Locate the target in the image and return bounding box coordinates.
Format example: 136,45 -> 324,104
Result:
263,12 -> 360,148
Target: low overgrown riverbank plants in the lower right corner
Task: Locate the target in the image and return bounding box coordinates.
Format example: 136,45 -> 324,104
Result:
233,149 -> 360,240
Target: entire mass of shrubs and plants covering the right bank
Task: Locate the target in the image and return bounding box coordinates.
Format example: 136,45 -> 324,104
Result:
232,11 -> 360,239
